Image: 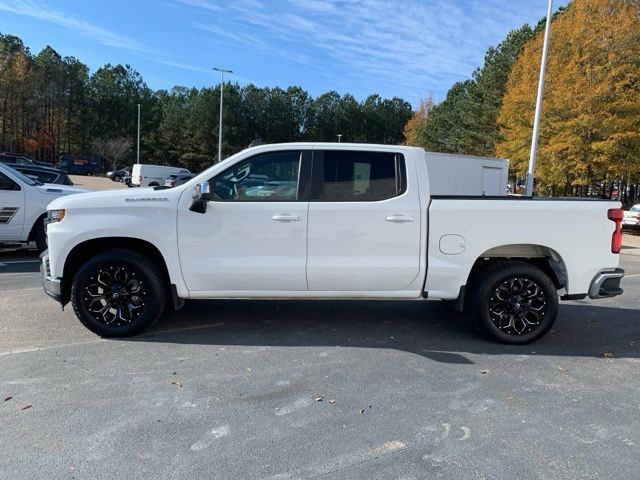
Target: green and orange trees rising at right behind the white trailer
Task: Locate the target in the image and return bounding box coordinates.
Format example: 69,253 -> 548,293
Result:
405,0 -> 640,203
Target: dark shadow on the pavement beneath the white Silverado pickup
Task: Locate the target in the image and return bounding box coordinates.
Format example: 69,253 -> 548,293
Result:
130,300 -> 640,364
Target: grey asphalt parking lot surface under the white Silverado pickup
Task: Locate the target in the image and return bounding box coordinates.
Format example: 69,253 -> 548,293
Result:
0,237 -> 640,480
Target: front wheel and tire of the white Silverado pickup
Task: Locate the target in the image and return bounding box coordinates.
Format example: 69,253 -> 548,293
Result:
71,249 -> 166,337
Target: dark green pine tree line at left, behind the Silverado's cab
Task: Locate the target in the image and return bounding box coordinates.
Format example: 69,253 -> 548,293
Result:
0,33 -> 413,171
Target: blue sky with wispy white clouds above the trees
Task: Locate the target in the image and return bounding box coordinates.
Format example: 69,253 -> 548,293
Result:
0,0 -> 567,105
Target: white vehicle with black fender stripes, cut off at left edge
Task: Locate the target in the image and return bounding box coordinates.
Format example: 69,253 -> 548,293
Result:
0,164 -> 87,252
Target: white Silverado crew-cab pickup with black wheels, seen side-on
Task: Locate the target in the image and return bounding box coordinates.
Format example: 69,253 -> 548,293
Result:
41,143 -> 624,343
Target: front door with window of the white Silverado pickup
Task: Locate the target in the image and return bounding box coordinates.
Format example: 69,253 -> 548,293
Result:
178,150 -> 310,295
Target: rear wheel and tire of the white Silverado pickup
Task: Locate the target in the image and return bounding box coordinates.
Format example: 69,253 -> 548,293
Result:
468,261 -> 558,344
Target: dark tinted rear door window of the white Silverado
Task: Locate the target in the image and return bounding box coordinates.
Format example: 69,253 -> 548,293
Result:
312,150 -> 406,202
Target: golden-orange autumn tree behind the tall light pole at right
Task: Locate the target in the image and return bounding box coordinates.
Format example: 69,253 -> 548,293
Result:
496,0 -> 640,193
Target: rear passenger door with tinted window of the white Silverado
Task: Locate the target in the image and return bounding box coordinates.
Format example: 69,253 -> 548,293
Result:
307,150 -> 421,292
